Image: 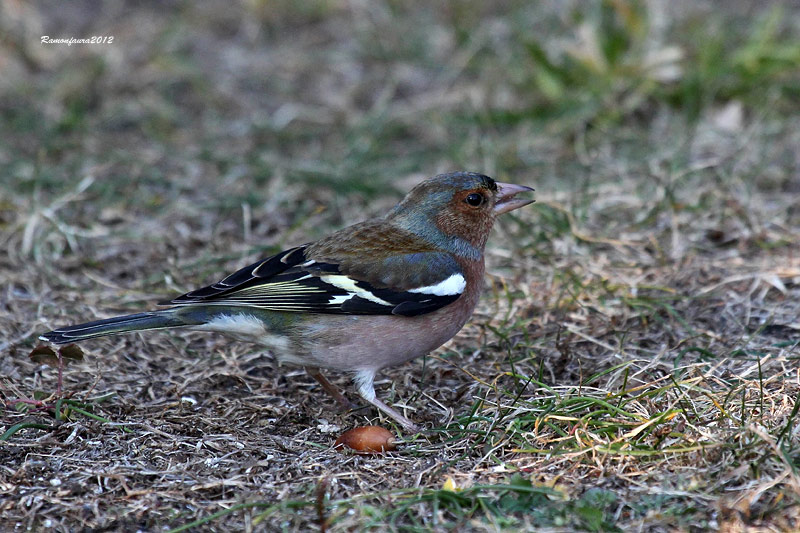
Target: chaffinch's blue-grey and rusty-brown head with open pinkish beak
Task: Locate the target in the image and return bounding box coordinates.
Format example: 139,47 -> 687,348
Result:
386,172 -> 534,256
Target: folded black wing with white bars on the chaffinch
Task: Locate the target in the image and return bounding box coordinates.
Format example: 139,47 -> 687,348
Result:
164,230 -> 466,316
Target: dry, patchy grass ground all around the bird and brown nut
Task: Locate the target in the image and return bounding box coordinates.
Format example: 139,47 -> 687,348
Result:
0,0 -> 800,531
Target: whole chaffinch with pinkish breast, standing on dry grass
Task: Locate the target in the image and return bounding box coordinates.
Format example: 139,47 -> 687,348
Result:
39,171 -> 534,432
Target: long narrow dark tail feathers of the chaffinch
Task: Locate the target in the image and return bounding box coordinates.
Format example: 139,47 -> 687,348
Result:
39,308 -> 202,344
